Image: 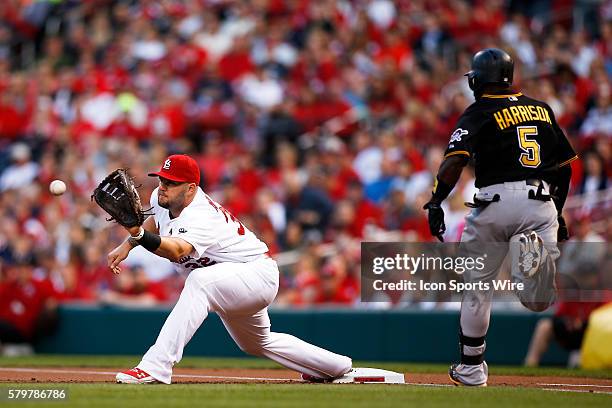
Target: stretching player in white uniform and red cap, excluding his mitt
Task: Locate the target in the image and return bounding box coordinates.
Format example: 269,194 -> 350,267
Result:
108,155 -> 352,384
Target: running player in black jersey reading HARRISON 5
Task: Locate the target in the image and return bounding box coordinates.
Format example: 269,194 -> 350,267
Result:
424,48 -> 577,386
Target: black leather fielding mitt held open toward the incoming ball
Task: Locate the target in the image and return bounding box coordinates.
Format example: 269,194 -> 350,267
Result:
91,169 -> 148,228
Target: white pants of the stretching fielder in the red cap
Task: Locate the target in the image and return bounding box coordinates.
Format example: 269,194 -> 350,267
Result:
138,256 -> 352,384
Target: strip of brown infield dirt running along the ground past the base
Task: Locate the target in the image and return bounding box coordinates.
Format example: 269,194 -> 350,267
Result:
0,367 -> 612,394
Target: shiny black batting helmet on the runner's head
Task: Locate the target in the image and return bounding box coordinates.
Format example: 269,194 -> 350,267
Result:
465,48 -> 514,92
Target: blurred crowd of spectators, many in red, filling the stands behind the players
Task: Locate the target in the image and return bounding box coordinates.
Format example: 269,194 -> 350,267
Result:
0,0 -> 612,333
